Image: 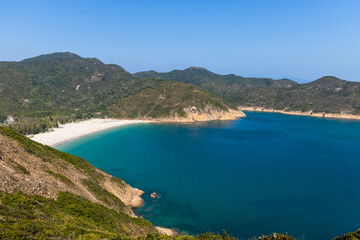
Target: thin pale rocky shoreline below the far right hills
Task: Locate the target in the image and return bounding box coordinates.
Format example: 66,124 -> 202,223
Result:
238,106 -> 360,120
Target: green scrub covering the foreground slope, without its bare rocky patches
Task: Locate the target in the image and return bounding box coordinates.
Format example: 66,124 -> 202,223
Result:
0,127 -> 155,239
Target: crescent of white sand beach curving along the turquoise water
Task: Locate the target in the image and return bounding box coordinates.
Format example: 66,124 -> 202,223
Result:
30,119 -> 150,146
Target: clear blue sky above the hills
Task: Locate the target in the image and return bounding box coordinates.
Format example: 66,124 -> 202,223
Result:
0,0 -> 360,81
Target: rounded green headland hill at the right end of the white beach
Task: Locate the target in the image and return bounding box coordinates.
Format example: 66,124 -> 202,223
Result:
114,81 -> 235,119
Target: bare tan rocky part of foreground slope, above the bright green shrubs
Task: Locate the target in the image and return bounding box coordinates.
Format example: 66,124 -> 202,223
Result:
0,127 -> 156,236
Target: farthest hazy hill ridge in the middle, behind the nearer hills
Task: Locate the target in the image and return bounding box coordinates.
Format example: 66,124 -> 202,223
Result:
134,67 -> 298,100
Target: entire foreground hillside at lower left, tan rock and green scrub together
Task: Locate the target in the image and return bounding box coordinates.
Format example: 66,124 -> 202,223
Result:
0,127 -> 156,239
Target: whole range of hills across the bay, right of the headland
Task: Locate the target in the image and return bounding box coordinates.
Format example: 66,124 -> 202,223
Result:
135,67 -> 360,115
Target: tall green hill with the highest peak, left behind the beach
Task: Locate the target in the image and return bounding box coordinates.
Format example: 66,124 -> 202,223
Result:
0,53 -> 141,117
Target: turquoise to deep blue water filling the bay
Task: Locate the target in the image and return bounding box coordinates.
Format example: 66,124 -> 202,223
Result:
57,112 -> 360,239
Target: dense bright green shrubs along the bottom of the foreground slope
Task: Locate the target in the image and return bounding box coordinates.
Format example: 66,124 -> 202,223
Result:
0,192 -> 152,239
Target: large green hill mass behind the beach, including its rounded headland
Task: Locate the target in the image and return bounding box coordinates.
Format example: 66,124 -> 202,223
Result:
0,52 -> 245,134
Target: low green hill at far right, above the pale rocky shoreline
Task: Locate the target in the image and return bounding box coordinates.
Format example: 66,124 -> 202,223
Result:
231,76 -> 360,115
